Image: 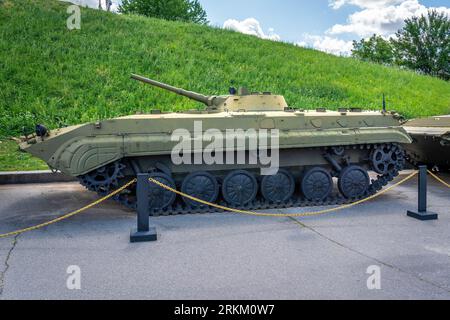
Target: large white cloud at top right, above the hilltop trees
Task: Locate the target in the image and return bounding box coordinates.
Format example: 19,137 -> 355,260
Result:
326,0 -> 450,37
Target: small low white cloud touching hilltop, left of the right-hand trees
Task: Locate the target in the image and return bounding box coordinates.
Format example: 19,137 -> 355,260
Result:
297,34 -> 353,56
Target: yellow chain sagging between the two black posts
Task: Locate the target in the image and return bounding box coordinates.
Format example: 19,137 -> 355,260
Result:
149,171 -> 418,217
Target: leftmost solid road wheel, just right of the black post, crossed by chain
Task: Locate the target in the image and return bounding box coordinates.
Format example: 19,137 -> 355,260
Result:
148,172 -> 177,211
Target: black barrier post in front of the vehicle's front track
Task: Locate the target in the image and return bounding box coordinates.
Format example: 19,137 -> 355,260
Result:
130,173 -> 158,243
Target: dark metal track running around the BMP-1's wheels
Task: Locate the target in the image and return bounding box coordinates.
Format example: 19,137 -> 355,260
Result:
79,144 -> 405,216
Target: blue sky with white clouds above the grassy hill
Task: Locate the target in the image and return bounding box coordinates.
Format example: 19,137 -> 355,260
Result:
69,0 -> 450,55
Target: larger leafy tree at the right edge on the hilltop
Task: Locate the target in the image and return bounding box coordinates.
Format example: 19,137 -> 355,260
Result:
392,10 -> 450,80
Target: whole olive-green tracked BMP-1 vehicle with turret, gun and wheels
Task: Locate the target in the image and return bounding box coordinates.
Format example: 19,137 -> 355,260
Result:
21,75 -> 411,215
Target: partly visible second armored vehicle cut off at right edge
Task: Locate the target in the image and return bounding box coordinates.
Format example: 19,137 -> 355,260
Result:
404,115 -> 450,170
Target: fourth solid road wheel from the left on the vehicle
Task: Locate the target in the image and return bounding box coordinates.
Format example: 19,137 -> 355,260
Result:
261,170 -> 295,203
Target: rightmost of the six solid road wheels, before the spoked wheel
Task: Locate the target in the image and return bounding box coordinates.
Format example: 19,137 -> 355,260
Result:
338,165 -> 370,199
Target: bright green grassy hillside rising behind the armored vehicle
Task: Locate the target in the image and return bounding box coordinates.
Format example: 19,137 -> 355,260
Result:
0,0 -> 450,171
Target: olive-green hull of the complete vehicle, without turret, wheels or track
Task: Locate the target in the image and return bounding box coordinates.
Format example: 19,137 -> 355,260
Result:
21,112 -> 412,176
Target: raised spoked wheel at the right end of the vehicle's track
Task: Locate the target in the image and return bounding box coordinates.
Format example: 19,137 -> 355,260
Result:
370,145 -> 404,174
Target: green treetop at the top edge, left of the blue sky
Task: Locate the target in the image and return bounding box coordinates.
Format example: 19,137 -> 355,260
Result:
119,0 -> 208,24
